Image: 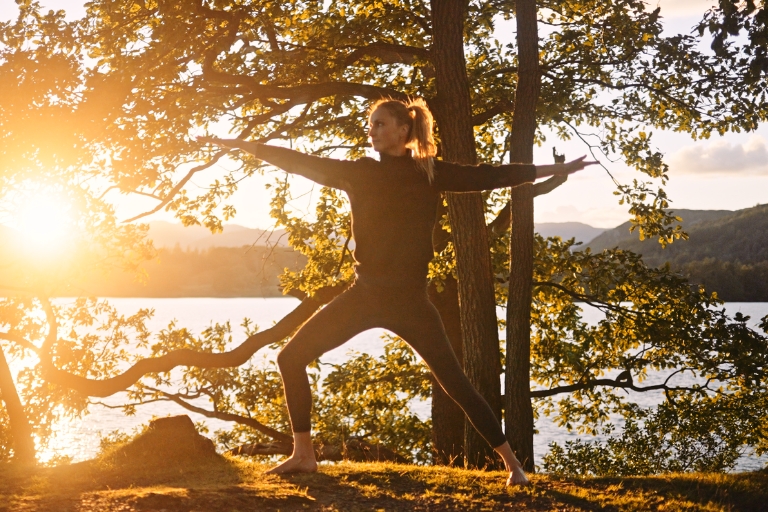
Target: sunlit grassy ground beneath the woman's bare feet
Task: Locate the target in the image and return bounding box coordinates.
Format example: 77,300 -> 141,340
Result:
0,457 -> 768,512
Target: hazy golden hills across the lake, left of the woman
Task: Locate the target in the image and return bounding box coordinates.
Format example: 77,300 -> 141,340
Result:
0,222 -> 306,297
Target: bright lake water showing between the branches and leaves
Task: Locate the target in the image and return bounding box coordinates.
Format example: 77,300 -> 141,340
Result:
34,298 -> 768,471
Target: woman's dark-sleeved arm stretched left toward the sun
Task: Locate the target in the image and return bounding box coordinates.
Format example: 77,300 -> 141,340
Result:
197,137 -> 355,190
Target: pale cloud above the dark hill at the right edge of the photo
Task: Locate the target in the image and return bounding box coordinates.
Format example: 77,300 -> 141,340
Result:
669,135 -> 768,176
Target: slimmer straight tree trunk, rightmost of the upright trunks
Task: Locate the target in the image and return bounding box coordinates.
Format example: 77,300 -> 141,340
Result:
504,0 -> 540,472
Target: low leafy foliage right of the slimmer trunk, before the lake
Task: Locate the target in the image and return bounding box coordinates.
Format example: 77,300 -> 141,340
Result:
531,239 -> 768,475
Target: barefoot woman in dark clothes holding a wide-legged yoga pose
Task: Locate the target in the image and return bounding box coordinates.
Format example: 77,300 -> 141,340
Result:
199,99 -> 594,485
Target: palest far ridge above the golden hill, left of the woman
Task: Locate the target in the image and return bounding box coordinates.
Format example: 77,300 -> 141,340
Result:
149,221 -> 288,250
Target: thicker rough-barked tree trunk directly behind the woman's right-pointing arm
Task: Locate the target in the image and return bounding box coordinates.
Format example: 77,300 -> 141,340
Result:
432,0 -> 501,467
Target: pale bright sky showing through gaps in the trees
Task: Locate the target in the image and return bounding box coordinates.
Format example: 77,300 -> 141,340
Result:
0,0 -> 768,229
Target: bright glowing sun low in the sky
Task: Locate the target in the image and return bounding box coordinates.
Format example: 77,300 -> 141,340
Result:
14,192 -> 72,245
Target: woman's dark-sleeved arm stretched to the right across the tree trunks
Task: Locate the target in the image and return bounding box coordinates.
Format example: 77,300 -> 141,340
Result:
435,156 -> 597,192
